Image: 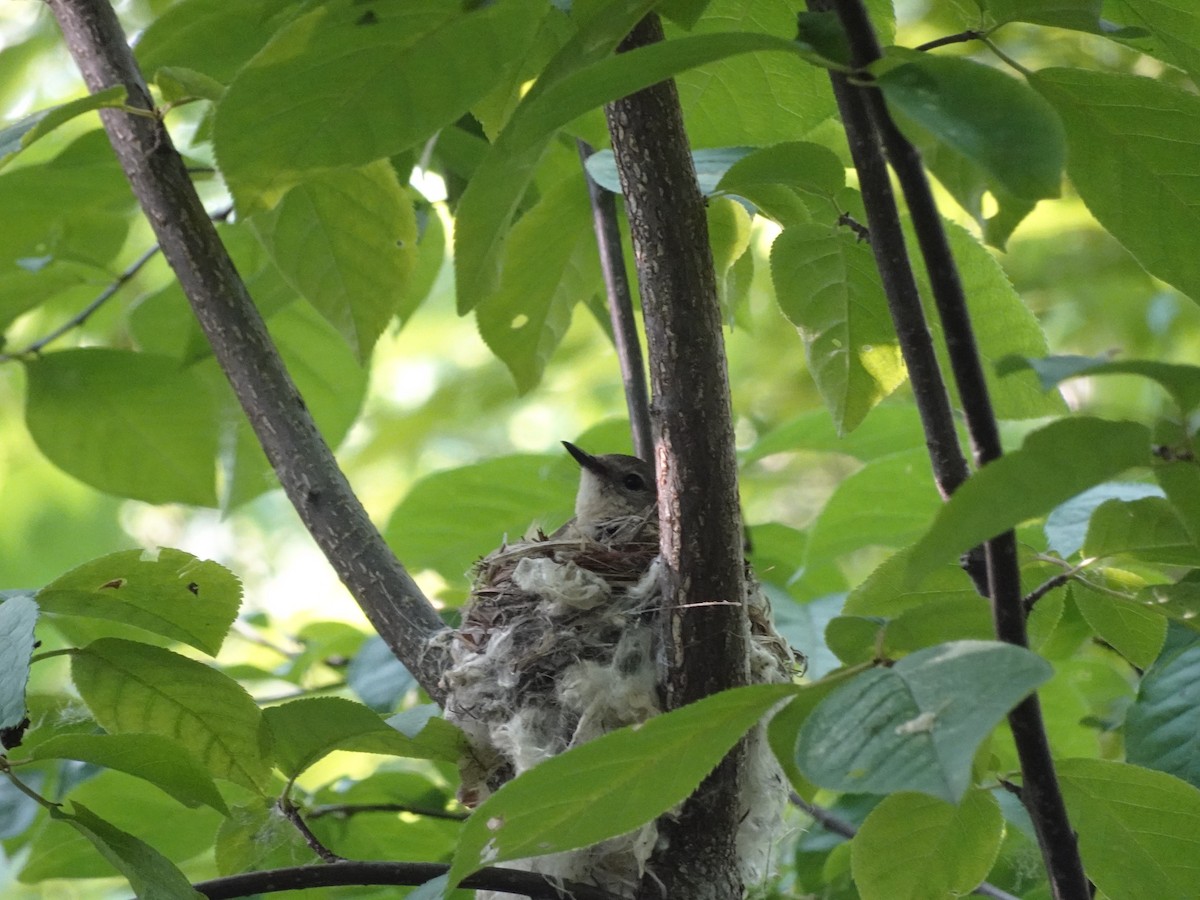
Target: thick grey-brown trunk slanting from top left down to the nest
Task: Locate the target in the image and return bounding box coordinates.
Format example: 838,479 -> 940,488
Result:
47,0 -> 443,697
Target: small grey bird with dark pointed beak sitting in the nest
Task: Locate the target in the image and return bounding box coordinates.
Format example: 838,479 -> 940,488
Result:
551,440 -> 658,540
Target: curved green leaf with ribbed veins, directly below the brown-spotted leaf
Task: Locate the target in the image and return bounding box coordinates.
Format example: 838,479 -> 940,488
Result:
71,637 -> 268,791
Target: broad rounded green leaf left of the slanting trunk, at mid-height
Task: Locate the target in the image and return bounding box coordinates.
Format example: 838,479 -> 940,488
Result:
25,347 -> 218,506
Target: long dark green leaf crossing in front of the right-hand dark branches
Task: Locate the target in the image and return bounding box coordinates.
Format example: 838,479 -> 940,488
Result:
908,416 -> 1150,583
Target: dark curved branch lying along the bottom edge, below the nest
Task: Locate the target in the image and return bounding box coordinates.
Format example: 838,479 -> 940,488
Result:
192,860 -> 622,900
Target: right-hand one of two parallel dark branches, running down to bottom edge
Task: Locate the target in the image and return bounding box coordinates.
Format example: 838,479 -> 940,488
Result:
835,0 -> 1091,900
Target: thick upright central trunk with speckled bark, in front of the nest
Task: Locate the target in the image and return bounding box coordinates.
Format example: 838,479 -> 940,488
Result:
607,16 -> 749,900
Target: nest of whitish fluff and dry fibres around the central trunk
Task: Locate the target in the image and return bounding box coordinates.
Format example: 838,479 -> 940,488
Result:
443,520 -> 794,900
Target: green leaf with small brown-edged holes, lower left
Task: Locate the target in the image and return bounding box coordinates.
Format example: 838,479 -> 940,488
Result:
37,547 -> 241,656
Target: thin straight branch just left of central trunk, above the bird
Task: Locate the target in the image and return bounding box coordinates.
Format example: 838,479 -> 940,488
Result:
576,140 -> 654,462
